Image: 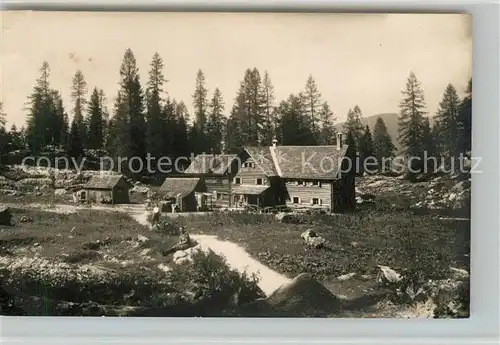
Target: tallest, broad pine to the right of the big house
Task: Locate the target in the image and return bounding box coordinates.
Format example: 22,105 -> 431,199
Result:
398,72 -> 426,171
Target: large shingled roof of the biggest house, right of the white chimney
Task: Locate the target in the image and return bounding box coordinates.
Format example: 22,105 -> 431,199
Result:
269,145 -> 348,180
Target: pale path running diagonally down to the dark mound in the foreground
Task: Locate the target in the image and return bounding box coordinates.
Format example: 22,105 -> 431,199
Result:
191,235 -> 290,296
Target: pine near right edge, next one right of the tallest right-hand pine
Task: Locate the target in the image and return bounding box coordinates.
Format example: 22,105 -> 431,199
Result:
436,84 -> 460,157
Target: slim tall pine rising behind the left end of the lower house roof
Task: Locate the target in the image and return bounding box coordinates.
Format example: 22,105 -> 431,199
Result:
193,69 -> 208,153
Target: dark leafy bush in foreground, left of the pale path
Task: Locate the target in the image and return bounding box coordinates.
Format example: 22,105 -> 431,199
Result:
170,250 -> 265,316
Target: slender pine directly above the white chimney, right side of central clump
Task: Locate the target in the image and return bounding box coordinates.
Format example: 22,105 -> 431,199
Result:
261,71 -> 279,146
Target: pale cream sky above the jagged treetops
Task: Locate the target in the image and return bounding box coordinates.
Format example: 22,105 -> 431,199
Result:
0,12 -> 472,125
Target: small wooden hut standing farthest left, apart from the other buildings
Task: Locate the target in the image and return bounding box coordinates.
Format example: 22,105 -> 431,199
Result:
78,175 -> 132,204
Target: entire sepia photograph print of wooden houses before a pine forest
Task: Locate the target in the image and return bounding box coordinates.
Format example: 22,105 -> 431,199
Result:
0,11 -> 470,319
